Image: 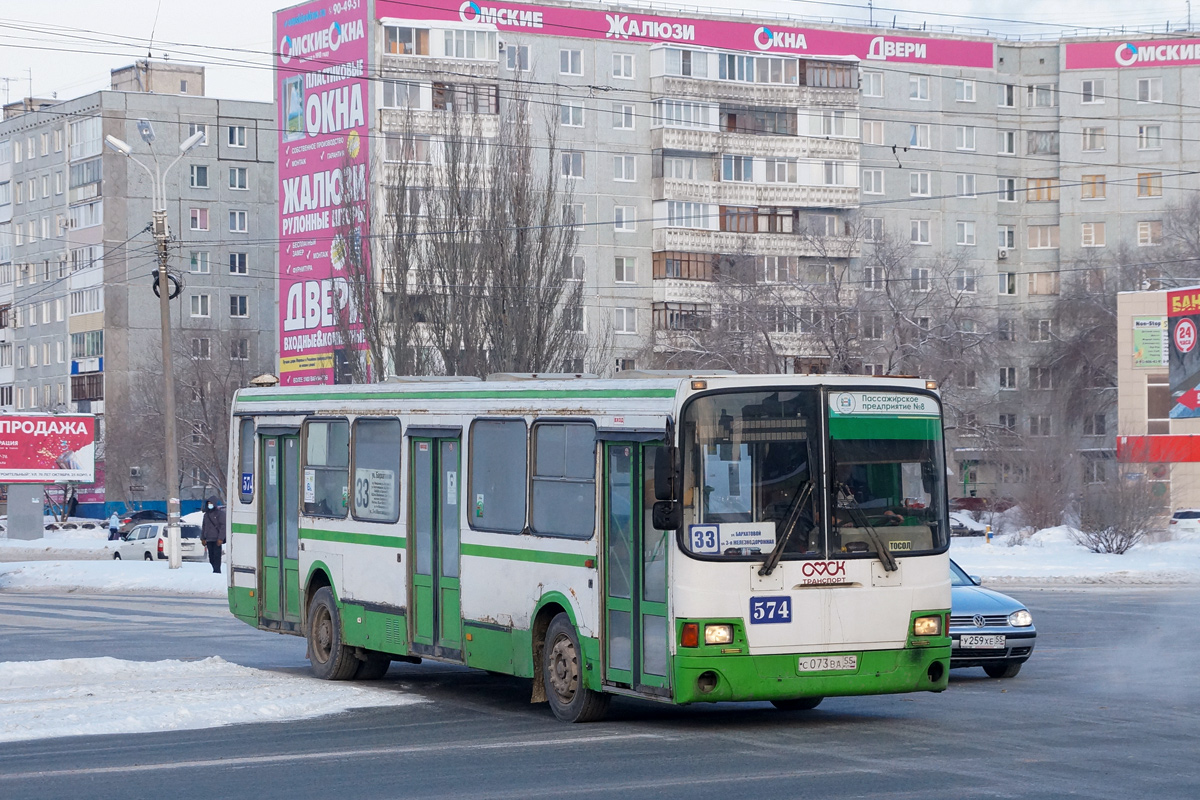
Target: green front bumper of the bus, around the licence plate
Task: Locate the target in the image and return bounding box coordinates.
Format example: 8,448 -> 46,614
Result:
673,642 -> 950,703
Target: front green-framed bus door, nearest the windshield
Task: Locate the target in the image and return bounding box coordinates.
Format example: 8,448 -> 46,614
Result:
605,443 -> 671,696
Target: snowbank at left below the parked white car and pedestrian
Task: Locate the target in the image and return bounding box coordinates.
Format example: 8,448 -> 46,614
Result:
0,558 -> 228,597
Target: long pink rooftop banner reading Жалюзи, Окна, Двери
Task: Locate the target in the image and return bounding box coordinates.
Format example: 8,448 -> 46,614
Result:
376,0 -> 995,70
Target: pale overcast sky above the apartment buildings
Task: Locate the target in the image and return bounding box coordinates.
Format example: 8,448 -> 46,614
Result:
0,0 -> 1200,101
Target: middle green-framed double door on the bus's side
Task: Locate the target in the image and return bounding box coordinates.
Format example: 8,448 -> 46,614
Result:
409,437 -> 462,661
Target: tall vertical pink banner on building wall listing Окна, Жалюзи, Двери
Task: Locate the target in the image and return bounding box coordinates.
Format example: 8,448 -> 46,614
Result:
275,0 -> 370,386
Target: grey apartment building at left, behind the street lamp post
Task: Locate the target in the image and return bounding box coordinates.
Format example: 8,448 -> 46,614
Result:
0,62 -> 276,512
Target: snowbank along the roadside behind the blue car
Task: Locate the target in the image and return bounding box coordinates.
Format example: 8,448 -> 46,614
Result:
950,525 -> 1200,584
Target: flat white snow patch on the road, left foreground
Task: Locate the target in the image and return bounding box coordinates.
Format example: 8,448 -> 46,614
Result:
0,657 -> 424,741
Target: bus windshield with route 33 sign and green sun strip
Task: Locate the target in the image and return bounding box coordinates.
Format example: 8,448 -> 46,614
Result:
680,387 -> 948,560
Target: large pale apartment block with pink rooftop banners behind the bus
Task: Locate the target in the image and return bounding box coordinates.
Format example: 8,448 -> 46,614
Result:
276,0 -> 1200,497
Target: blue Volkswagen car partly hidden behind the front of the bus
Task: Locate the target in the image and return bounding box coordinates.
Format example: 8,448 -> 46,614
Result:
950,560 -> 1038,678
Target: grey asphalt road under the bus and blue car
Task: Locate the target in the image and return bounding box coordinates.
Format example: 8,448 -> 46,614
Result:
0,587 -> 1200,800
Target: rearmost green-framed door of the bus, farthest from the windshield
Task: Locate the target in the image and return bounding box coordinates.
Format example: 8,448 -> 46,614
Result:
258,435 -> 301,627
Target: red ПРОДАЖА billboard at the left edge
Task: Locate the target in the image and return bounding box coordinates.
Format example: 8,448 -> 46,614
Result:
0,414 -> 96,483
